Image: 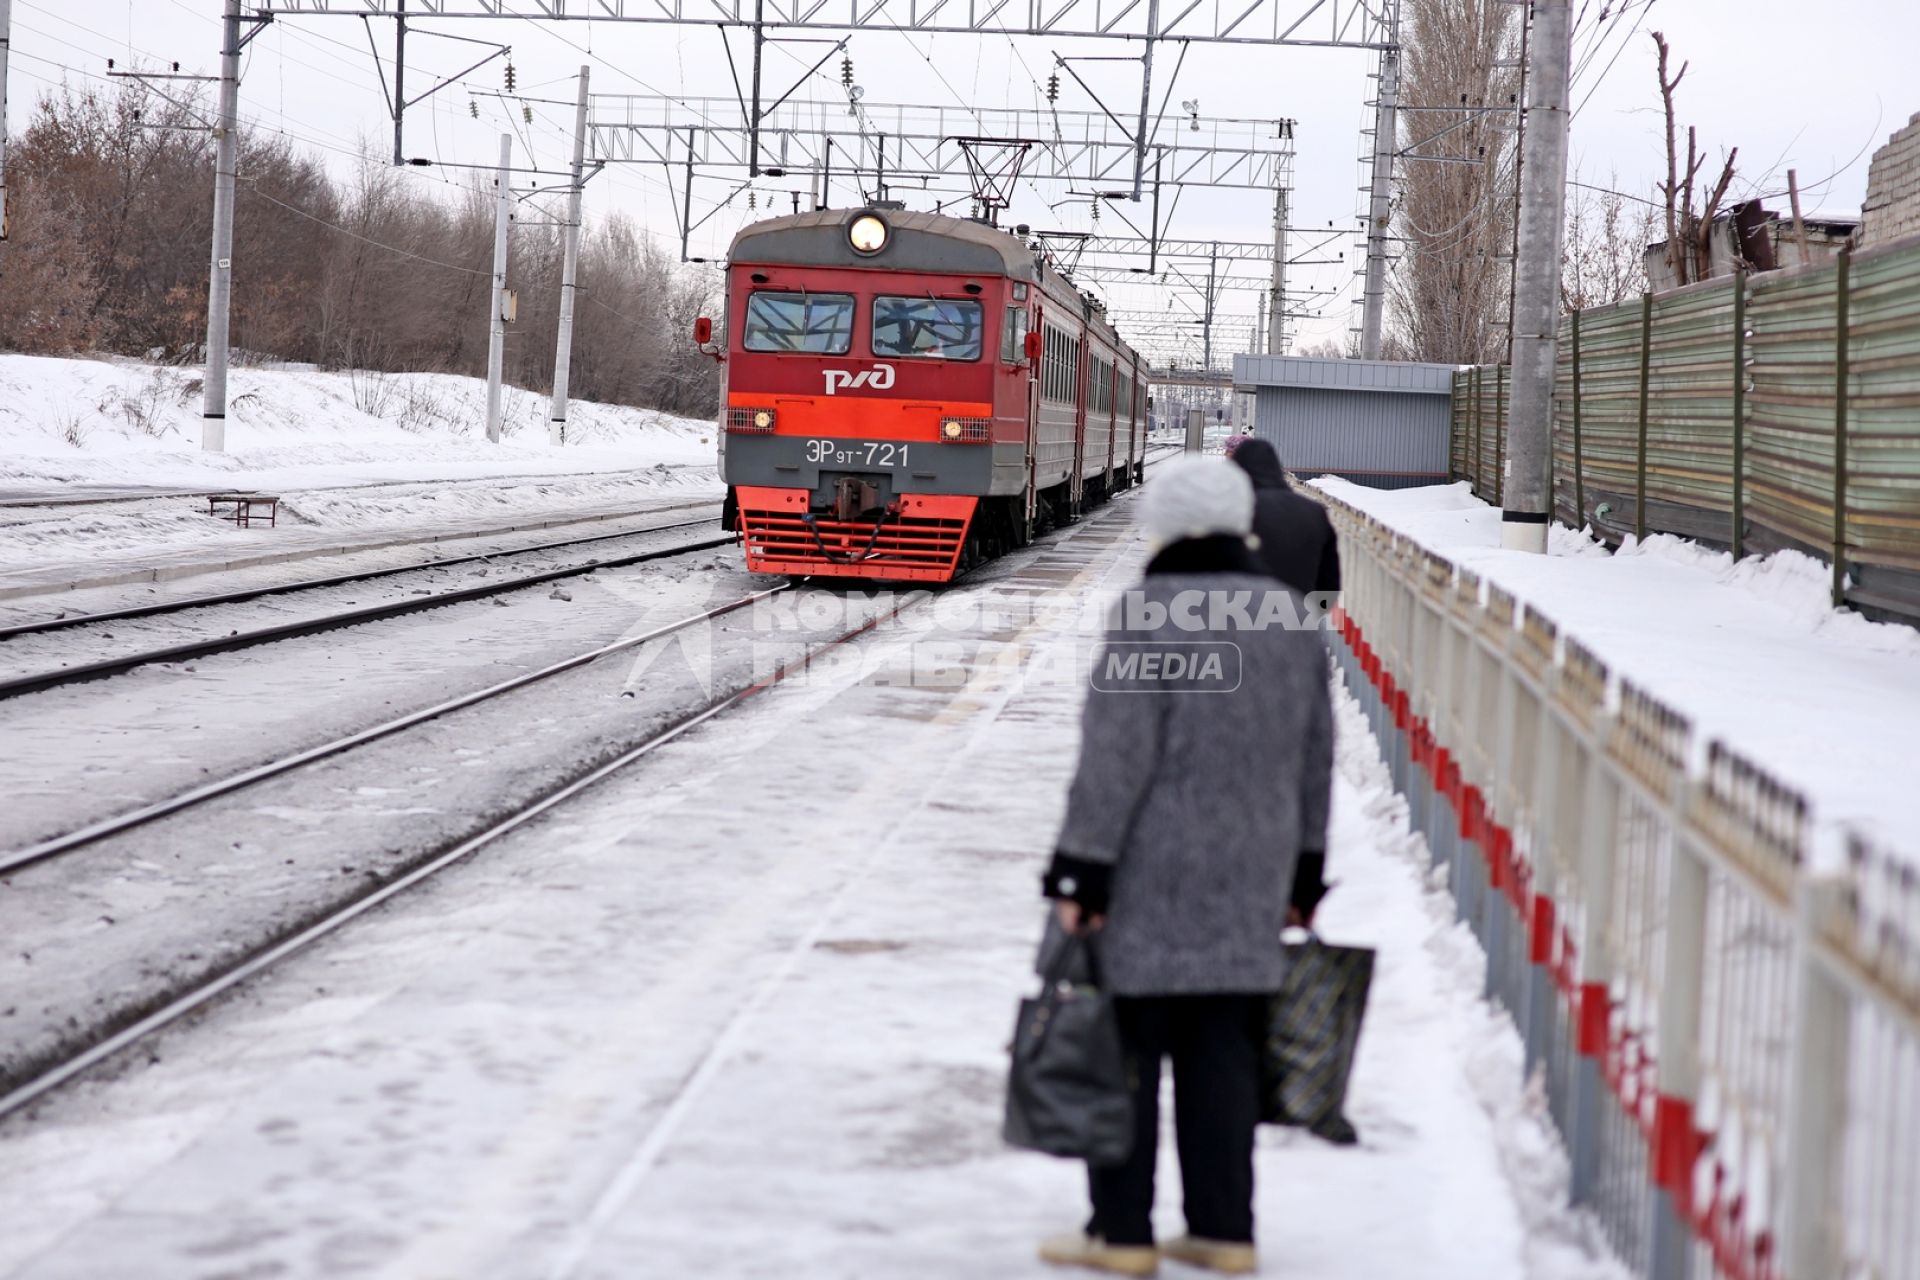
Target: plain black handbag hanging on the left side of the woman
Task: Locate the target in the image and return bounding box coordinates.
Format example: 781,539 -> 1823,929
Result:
1002,936 -> 1133,1165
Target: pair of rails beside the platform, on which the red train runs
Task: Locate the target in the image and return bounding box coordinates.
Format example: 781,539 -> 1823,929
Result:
0,475 -> 1152,1117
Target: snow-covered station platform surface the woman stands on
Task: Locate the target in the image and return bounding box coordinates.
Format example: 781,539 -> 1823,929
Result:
0,522 -> 1619,1280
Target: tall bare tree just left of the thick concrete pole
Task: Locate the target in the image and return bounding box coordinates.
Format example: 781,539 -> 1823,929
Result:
1392,0 -> 1521,363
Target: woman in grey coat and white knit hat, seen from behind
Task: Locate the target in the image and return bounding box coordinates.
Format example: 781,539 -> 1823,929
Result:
1041,459 -> 1332,1274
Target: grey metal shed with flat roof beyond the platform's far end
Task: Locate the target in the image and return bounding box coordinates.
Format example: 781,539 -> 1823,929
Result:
1233,355 -> 1453,489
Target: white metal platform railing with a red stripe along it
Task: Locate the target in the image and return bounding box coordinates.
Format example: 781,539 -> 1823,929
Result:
1302,489 -> 1920,1280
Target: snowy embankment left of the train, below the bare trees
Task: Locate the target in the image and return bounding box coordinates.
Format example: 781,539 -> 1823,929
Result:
0,355 -> 720,587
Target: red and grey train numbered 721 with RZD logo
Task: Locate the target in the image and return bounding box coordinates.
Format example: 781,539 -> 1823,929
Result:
710,209 -> 1146,581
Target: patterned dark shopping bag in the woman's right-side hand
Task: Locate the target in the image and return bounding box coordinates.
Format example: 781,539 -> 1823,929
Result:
1260,933 -> 1373,1146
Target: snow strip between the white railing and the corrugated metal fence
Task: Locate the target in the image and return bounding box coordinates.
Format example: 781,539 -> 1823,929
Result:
1313,480 -> 1920,860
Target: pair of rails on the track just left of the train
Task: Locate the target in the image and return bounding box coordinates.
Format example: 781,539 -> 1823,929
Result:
0,518 -> 733,700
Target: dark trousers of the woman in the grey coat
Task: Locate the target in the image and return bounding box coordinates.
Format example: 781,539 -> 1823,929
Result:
1087,996 -> 1267,1244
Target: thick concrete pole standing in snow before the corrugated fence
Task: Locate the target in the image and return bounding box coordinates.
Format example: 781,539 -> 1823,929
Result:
1500,0 -> 1572,555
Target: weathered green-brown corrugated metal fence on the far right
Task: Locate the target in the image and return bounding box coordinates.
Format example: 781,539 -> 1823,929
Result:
1450,236 -> 1920,620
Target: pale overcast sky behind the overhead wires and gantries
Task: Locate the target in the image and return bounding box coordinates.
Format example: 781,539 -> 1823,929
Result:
8,0 -> 1920,347
